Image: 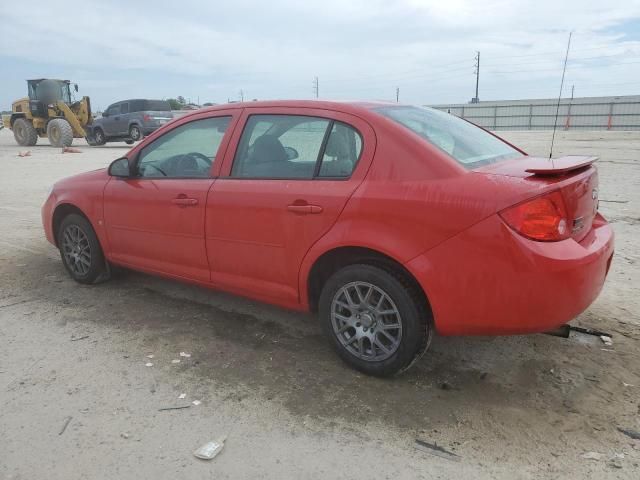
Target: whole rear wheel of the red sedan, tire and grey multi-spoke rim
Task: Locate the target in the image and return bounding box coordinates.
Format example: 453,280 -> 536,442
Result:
319,265 -> 432,376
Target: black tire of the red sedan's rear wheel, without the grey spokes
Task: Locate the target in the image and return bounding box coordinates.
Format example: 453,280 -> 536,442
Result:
318,264 -> 433,377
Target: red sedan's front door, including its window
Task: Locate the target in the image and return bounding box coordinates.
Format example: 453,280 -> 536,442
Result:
104,111 -> 239,282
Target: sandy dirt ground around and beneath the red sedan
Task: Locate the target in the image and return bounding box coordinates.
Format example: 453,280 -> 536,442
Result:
0,130 -> 640,480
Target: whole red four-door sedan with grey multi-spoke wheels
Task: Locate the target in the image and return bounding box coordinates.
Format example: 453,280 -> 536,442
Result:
42,101 -> 613,375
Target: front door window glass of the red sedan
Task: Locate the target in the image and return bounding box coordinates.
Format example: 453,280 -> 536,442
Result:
137,117 -> 231,178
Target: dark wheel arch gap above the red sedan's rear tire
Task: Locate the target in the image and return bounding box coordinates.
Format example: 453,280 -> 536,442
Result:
305,246 -> 433,318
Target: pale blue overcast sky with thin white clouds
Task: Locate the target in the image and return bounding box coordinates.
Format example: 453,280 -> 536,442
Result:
0,0 -> 640,109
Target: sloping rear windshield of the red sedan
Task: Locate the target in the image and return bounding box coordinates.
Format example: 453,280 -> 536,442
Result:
375,106 -> 522,169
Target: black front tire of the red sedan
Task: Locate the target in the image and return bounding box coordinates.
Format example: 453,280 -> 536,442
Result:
57,213 -> 109,284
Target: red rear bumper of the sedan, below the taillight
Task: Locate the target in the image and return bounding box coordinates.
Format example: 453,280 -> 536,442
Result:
406,214 -> 614,335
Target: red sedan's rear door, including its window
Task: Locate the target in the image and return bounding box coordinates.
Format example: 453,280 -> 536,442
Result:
206,108 -> 375,306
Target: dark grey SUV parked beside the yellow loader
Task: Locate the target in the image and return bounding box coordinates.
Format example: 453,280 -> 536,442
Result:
89,99 -> 173,145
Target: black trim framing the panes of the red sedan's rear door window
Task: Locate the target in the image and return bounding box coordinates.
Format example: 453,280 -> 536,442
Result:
228,112 -> 364,182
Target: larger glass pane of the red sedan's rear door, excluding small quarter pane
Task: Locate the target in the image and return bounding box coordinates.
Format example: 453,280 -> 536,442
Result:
231,115 -> 331,178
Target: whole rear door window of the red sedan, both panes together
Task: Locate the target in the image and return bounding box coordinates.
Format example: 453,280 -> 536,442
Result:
231,115 -> 362,179
